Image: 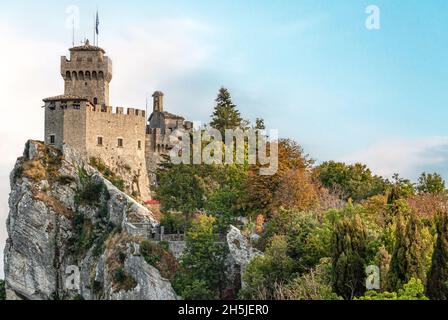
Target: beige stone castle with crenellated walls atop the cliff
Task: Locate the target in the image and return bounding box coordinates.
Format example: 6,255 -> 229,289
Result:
43,40 -> 192,200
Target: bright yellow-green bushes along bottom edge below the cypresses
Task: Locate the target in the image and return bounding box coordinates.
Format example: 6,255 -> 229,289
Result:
357,278 -> 428,300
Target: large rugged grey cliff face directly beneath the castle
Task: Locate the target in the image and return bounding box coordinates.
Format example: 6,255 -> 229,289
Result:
4,141 -> 176,300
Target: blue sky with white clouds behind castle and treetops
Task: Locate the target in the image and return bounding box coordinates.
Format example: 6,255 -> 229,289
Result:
0,0 -> 448,278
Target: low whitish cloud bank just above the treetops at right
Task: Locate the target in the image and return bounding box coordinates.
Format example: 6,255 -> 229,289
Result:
341,136 -> 448,180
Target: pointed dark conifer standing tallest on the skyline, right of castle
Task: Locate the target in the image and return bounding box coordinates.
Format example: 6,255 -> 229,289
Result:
210,87 -> 243,136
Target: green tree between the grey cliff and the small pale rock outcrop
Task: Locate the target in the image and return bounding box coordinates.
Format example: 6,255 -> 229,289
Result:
176,215 -> 228,299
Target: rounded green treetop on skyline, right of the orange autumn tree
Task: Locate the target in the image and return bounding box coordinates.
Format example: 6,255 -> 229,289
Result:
315,161 -> 386,201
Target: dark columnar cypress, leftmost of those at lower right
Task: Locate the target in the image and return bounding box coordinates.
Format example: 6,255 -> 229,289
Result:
332,214 -> 366,300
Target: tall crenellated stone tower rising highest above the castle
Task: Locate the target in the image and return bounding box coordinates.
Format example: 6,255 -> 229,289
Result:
61,40 -> 112,106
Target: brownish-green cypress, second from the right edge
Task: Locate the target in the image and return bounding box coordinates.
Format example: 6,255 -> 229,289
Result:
387,207 -> 426,291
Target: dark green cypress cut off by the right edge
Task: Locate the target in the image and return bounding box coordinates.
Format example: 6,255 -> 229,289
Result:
426,212 -> 448,300
